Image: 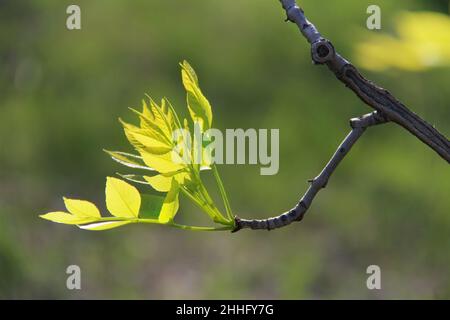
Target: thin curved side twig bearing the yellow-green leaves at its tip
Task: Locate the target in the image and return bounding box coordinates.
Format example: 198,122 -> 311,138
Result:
234,111 -> 388,232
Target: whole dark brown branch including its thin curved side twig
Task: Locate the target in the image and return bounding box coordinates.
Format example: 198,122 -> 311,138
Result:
233,0 -> 450,232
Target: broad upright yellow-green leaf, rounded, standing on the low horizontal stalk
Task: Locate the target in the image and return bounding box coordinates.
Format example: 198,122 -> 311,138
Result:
105,177 -> 141,218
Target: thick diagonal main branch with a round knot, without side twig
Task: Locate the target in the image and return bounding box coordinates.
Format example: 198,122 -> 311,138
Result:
280,0 -> 450,163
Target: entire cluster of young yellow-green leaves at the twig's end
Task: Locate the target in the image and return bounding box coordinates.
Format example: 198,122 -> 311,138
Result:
41,61 -> 236,234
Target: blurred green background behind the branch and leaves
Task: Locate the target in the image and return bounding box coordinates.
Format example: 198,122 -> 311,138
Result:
0,0 -> 450,299
